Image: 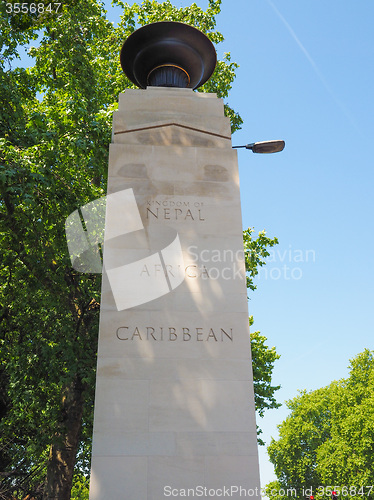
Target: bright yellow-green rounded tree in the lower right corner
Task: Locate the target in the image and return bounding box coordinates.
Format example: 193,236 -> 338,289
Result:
268,349 -> 374,498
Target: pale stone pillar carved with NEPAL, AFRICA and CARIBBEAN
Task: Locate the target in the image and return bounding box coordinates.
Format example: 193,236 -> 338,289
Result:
90,87 -> 260,500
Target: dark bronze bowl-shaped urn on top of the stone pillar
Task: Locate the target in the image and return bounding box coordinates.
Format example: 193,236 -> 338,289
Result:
120,21 -> 217,89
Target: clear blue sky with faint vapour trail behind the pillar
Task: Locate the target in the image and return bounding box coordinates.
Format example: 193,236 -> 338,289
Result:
18,0 -> 374,485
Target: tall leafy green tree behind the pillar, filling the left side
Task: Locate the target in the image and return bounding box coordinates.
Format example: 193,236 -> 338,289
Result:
0,0 -> 280,500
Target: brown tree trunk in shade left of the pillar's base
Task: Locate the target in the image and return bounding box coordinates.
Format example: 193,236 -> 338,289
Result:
43,376 -> 84,500
